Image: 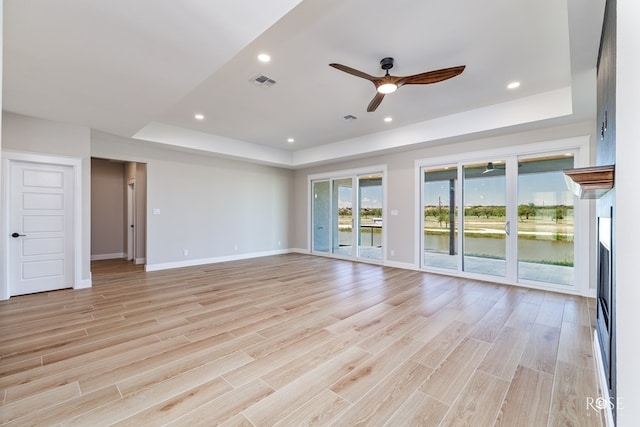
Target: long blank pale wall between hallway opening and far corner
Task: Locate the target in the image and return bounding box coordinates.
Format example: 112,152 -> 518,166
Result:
91,132 -> 296,270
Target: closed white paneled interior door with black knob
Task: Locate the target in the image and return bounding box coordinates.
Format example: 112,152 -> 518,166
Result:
9,161 -> 74,295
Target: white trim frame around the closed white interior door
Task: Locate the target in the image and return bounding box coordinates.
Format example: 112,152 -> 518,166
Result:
0,149 -> 87,300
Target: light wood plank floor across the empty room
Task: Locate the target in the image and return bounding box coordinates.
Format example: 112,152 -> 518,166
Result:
0,254 -> 601,427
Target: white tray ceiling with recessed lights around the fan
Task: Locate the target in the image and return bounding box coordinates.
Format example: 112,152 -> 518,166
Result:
3,0 -> 604,167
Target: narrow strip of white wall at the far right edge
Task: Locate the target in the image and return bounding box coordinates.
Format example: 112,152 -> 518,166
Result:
615,0 -> 640,427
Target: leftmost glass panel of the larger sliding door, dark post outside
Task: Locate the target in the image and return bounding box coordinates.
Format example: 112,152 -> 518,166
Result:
422,166 -> 458,270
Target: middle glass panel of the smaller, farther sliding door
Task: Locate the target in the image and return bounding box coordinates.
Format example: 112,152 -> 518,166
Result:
332,178 -> 353,256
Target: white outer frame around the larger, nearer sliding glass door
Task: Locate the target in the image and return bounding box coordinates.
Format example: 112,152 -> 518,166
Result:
414,135 -> 595,296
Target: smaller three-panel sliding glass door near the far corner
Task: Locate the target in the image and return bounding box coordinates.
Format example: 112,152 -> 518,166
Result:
311,169 -> 384,261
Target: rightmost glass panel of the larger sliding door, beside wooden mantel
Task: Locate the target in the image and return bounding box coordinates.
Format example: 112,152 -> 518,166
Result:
518,155 -> 574,285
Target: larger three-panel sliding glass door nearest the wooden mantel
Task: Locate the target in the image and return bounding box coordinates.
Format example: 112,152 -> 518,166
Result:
420,153 -> 575,286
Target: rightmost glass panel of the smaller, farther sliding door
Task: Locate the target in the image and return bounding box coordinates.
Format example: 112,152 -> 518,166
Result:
358,175 -> 382,261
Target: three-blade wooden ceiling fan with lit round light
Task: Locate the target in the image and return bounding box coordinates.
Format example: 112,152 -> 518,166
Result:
329,57 -> 465,112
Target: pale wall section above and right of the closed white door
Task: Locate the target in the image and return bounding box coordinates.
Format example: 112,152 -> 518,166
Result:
2,112 -> 91,285
